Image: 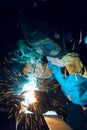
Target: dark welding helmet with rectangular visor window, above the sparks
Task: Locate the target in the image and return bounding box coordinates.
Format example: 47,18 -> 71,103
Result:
20,1 -> 72,58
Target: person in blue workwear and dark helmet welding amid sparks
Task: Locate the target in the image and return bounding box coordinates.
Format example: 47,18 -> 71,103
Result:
20,0 -> 87,106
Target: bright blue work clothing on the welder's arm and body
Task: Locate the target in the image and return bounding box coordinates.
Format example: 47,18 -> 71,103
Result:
48,62 -> 87,106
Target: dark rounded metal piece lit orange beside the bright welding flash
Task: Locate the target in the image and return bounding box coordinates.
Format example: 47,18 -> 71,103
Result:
28,90 -> 50,115
